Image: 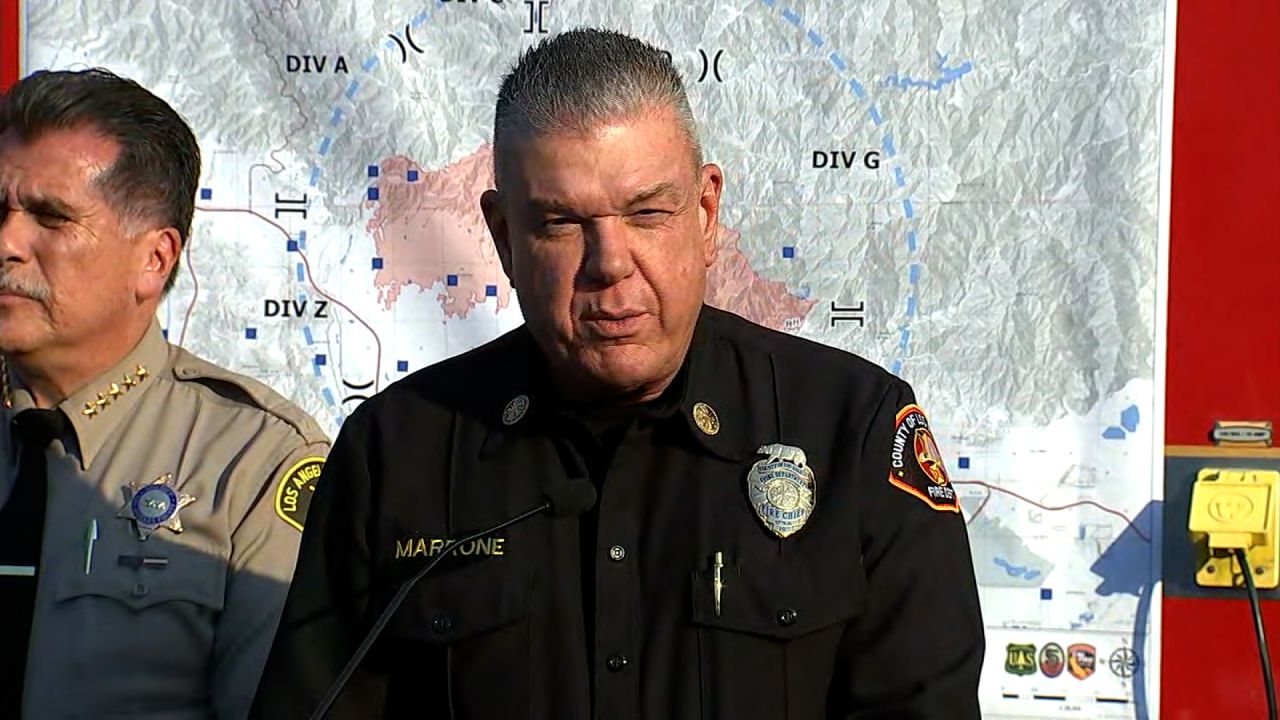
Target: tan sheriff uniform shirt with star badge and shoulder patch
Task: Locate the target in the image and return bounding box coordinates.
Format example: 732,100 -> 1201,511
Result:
0,325 -> 329,720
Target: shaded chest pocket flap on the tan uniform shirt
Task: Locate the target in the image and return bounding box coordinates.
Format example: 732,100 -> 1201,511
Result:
54,537 -> 227,611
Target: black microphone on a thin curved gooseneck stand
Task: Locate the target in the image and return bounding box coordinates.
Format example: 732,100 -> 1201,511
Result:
311,478 -> 595,720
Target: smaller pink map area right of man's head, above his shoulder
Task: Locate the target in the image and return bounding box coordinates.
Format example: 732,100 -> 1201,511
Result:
707,225 -> 817,331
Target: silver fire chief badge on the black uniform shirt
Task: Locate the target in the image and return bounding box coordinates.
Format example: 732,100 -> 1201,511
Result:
746,443 -> 817,538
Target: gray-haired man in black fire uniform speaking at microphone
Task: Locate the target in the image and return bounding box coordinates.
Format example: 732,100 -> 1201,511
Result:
256,25 -> 984,720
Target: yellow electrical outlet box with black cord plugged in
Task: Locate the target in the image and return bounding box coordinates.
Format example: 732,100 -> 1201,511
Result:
1188,468 -> 1280,588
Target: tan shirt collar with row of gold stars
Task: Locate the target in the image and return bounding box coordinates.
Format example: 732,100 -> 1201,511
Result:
9,322 -> 169,470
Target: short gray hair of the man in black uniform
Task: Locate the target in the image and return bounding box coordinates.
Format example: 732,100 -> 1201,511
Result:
493,28 -> 703,184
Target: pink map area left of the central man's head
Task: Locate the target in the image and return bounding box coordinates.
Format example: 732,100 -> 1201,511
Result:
366,145 -> 511,318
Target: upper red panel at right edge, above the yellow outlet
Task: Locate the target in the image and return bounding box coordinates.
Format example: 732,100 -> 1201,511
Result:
1165,0 -> 1280,445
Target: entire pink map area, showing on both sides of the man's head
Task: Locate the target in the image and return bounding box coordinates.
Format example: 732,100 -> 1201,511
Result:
366,143 -> 815,331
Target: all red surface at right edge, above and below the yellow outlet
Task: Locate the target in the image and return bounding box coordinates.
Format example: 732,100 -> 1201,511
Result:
1161,0 -> 1280,720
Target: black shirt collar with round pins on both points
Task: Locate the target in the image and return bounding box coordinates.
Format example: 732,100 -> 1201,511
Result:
483,306 -> 776,461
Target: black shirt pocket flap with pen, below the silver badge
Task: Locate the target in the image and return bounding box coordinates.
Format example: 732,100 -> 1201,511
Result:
691,550 -> 865,641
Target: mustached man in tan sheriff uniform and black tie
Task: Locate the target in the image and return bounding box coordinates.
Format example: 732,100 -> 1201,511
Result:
0,70 -> 328,720
